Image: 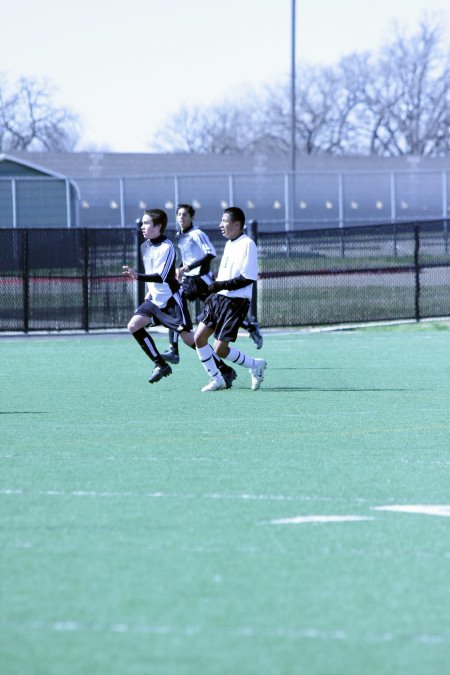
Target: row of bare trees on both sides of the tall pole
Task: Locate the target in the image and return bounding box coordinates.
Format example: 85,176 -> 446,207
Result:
150,18 -> 450,156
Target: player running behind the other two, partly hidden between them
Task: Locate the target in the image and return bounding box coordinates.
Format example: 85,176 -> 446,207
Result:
162,204 -> 263,363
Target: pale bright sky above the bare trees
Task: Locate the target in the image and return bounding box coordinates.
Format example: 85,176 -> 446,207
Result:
0,0 -> 450,152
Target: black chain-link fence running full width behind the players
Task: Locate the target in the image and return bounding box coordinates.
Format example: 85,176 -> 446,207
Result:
0,220 -> 450,332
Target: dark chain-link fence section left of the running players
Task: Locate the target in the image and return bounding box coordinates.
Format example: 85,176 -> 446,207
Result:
0,228 -> 137,332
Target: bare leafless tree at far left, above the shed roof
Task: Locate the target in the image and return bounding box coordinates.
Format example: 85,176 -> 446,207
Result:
0,76 -> 79,152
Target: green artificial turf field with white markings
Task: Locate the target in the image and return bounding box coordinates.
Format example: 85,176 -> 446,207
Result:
0,323 -> 450,675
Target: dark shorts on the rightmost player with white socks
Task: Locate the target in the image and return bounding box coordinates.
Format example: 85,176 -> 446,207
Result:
198,293 -> 250,342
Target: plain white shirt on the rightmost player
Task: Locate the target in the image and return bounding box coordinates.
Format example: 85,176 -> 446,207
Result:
217,234 -> 258,299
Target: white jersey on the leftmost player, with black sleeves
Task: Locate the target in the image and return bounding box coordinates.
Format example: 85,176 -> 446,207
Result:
141,239 -> 175,307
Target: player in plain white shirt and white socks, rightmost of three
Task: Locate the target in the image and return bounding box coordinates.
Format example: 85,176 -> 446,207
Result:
195,206 -> 267,391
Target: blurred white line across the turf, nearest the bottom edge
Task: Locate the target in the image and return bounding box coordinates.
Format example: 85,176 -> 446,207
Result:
0,619 -> 450,645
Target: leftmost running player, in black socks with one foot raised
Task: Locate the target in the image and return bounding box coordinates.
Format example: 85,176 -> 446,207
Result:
122,209 -> 236,388
